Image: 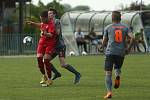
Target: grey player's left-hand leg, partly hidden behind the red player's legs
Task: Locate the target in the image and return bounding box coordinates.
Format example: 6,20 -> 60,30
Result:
50,53 -> 61,80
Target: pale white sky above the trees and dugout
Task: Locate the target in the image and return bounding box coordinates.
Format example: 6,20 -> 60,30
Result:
32,0 -> 150,11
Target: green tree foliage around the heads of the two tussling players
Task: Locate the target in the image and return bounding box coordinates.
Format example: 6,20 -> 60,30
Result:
24,0 -> 64,33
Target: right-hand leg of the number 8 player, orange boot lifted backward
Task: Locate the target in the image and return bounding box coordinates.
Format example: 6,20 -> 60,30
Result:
114,56 -> 124,89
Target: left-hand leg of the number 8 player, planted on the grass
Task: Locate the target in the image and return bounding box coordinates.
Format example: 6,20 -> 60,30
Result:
104,55 -> 113,99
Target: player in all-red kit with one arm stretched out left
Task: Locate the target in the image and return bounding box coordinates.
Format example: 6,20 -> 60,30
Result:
27,10 -> 56,85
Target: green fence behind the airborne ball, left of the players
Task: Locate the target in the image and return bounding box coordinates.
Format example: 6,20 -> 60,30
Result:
0,34 -> 39,55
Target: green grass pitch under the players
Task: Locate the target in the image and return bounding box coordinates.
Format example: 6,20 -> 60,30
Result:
0,54 -> 150,100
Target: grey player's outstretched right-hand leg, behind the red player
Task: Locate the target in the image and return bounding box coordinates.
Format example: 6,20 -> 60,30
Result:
58,47 -> 81,84
